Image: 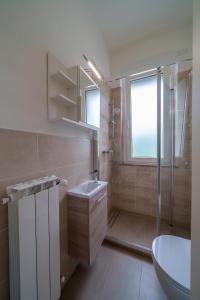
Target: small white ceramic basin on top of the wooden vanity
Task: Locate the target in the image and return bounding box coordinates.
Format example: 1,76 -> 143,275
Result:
67,180 -> 107,199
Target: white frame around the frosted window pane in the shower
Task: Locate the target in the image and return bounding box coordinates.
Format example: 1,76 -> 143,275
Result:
122,70 -> 157,165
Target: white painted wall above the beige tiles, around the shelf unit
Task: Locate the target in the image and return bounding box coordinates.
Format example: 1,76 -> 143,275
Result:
0,0 -> 109,136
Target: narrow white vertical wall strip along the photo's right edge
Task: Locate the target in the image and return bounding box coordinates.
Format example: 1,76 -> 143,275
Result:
192,0 -> 200,300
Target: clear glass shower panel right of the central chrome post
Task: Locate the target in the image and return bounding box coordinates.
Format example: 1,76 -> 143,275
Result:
159,61 -> 192,238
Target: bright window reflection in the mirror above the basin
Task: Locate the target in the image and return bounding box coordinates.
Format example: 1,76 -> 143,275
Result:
85,88 -> 100,127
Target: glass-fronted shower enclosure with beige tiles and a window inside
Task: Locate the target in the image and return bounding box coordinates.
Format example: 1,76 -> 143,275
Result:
107,60 -> 192,253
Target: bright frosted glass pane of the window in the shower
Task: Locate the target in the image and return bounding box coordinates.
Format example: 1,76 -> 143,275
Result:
130,75 -> 157,158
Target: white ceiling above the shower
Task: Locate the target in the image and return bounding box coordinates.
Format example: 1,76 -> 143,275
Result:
85,0 -> 193,51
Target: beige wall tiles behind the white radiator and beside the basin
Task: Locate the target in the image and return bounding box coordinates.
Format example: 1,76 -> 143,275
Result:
0,129 -> 92,290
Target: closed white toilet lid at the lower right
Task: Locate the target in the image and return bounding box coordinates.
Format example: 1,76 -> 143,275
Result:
152,235 -> 191,290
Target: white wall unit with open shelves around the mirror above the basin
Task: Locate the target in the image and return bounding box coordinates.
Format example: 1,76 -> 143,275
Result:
47,53 -> 99,132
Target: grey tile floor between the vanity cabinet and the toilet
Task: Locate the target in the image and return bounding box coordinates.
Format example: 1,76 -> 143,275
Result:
61,243 -> 167,300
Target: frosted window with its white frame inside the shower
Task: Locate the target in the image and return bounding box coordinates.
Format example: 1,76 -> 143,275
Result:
125,74 -> 163,164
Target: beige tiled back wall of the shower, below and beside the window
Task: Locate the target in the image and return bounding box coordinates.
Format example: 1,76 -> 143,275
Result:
111,88 -> 191,225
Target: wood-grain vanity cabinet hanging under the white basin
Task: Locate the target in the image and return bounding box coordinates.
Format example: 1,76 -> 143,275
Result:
68,188 -> 107,265
